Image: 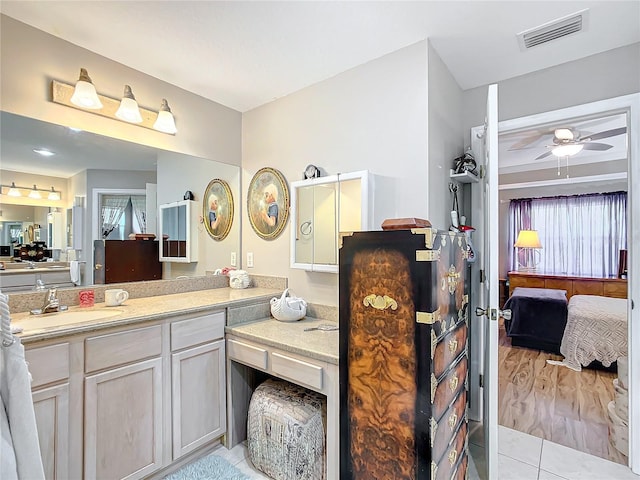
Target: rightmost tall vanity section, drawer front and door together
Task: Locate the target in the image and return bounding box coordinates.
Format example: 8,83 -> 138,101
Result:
171,311 -> 226,460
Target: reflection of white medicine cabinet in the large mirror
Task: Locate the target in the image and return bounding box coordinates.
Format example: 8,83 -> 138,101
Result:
158,200 -> 199,263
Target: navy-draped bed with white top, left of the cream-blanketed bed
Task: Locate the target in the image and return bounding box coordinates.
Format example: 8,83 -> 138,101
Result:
504,287 -> 568,354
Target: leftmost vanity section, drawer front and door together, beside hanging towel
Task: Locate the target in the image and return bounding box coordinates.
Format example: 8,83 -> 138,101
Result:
25,342 -> 71,480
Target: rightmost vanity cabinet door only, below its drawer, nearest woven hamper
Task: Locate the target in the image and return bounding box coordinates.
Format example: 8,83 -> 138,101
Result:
171,340 -> 227,459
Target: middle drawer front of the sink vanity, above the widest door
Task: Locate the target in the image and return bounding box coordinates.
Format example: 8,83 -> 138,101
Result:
84,325 -> 162,373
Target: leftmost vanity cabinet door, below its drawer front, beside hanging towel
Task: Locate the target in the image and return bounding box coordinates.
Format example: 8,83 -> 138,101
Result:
33,383 -> 69,479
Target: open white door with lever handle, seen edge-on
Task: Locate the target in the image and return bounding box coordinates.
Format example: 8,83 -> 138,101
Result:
476,85 -> 500,478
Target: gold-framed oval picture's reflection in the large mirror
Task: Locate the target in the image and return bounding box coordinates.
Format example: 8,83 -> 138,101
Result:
202,178 -> 233,240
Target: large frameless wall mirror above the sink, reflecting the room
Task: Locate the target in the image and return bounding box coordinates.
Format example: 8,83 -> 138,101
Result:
0,112 -> 241,291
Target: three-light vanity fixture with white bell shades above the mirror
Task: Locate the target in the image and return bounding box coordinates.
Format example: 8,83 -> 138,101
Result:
51,68 -> 177,135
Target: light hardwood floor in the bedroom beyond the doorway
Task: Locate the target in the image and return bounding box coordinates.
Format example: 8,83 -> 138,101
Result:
498,322 -> 628,465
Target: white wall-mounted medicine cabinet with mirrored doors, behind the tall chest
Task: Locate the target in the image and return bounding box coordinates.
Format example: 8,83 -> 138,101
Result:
291,170 -> 373,273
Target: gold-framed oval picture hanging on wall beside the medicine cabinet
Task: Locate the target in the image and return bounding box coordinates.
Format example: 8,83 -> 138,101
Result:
247,167 -> 289,240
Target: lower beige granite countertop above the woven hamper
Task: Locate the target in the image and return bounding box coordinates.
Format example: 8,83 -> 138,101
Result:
225,317 -> 340,365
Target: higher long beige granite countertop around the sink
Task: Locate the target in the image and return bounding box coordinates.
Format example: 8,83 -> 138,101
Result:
11,287 -> 282,344
